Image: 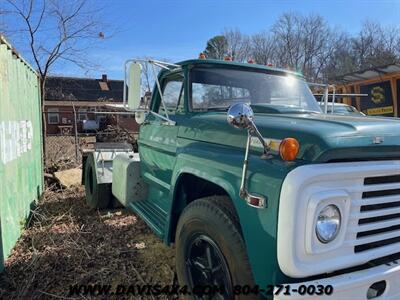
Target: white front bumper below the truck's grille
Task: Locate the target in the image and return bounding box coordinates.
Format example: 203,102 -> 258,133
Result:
274,260 -> 400,300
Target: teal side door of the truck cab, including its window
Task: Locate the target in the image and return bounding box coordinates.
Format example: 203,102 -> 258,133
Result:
135,73 -> 184,232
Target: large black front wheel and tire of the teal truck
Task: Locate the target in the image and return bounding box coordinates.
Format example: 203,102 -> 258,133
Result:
176,196 -> 256,299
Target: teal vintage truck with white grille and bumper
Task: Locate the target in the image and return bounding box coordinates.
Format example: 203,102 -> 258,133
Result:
83,59 -> 400,299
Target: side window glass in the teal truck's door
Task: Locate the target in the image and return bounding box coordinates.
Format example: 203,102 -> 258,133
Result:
158,79 -> 184,114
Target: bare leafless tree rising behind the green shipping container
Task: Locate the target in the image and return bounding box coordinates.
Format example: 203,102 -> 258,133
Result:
6,0 -> 104,155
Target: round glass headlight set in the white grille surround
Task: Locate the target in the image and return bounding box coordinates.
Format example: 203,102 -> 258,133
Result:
315,204 -> 341,244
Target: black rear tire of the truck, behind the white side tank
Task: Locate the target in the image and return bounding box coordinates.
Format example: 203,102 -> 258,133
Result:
85,154 -> 113,209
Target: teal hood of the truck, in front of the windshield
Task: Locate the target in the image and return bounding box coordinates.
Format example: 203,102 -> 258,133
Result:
178,112 -> 400,162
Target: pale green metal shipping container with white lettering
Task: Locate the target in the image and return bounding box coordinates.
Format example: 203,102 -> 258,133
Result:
0,36 -> 43,271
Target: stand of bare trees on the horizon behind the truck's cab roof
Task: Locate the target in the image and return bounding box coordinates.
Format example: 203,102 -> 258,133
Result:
207,13 -> 400,81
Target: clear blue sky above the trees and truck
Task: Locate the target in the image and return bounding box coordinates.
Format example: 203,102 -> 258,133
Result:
0,0 -> 400,79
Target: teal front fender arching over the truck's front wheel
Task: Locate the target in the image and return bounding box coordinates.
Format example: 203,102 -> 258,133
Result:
166,140 -> 293,287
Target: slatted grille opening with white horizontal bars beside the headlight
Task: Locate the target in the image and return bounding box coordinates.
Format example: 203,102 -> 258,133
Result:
354,175 -> 400,253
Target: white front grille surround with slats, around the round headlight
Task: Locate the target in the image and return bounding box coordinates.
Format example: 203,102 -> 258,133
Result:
278,160 -> 400,277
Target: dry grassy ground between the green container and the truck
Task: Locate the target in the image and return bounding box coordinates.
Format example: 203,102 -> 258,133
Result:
0,187 -> 175,299
